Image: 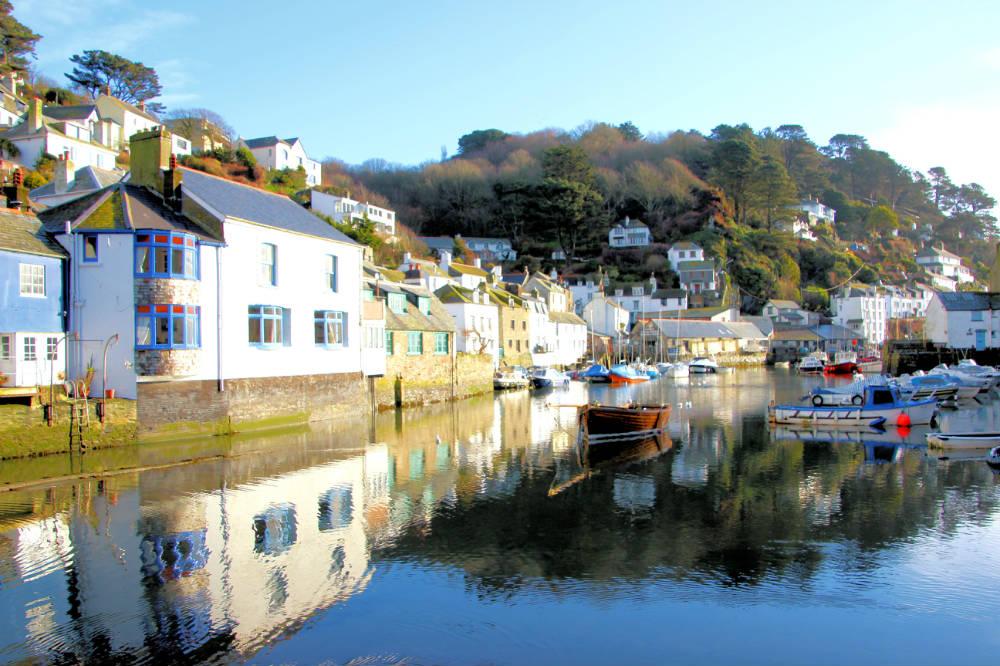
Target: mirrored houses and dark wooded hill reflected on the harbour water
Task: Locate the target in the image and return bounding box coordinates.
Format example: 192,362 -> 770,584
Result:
0,371 -> 998,661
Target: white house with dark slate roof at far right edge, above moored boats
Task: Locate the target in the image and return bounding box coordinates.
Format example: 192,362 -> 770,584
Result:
924,291 -> 1000,350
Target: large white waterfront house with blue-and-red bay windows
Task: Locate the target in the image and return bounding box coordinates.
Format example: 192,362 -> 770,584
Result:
41,128 -> 364,428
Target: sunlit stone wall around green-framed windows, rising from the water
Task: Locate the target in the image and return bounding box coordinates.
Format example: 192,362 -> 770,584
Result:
375,331 -> 493,409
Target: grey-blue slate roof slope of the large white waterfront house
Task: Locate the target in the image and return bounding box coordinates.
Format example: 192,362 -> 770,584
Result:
181,167 -> 357,245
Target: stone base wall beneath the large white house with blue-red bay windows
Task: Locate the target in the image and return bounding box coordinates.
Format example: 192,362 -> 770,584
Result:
138,373 -> 370,440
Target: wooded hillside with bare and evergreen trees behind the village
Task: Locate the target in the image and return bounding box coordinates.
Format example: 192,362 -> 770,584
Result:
324,123 -> 996,309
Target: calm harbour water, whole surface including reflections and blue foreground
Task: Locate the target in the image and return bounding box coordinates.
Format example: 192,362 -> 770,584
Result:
0,370 -> 1000,665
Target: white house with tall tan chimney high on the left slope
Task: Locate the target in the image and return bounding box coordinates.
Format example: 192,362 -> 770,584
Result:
0,97 -> 118,170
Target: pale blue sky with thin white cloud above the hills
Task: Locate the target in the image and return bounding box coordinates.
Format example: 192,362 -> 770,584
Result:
14,0 -> 1000,196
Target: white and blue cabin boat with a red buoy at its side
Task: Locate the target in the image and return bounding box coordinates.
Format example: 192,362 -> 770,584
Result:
767,384 -> 938,428
